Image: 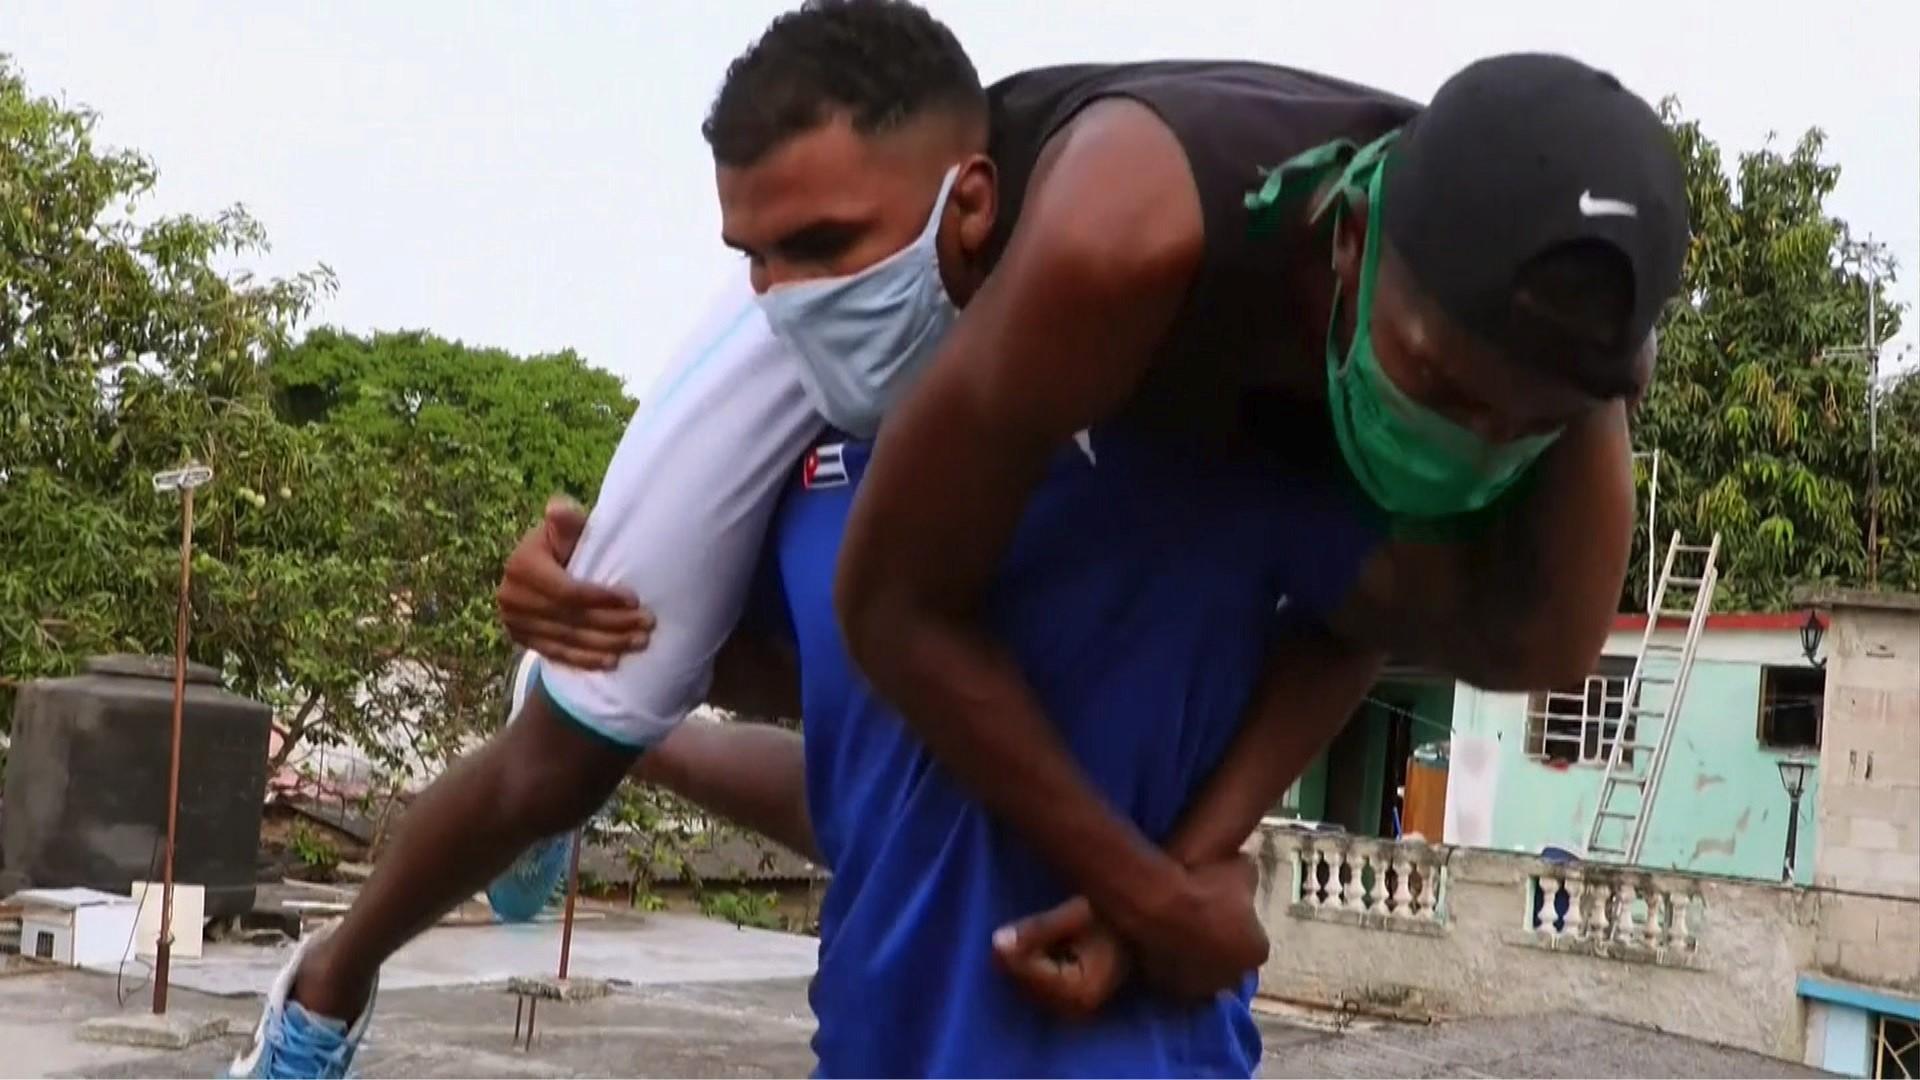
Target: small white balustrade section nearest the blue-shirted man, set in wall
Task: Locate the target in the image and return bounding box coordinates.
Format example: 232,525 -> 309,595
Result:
1292,836 -> 1446,922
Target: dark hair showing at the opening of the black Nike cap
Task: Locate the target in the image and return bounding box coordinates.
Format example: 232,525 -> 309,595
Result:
1503,240 -> 1640,400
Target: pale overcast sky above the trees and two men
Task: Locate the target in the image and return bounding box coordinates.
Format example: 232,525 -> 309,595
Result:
0,0 -> 1920,392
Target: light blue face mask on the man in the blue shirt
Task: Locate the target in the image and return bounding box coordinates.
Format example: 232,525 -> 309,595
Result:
760,165 -> 960,438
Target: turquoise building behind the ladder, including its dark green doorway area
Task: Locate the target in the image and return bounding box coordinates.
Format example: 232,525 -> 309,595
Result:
1275,615 -> 1826,884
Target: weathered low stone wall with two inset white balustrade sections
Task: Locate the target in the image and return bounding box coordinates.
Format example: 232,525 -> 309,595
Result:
1248,824 -> 1920,1059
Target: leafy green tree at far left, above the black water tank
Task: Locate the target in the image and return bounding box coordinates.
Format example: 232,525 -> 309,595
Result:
0,61 -> 342,714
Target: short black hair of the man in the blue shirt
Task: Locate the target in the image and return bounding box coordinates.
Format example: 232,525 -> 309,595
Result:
701,0 -> 987,167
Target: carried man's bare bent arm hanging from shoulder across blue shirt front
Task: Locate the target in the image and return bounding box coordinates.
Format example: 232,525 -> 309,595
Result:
835,102 -> 1202,932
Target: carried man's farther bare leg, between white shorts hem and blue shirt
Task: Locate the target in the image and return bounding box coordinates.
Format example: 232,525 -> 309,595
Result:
634,721 -> 822,863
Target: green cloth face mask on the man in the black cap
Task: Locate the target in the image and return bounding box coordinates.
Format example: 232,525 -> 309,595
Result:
1319,136 -> 1559,519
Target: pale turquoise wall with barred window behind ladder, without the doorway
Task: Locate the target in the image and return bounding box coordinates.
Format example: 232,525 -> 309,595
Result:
1446,615 -> 1826,884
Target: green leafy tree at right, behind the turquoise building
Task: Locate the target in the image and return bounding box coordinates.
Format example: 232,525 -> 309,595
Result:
1622,102 -> 1920,611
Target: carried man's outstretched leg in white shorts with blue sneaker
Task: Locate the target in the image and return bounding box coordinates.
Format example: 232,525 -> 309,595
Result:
234,269 -> 822,1076
